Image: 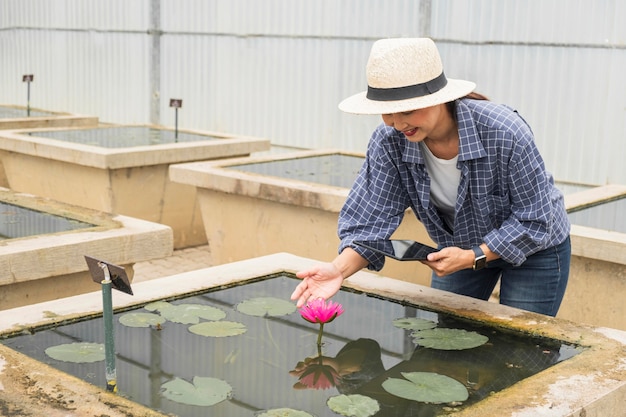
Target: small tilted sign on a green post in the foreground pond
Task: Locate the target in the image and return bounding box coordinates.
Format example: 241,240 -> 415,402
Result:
85,256 -> 133,392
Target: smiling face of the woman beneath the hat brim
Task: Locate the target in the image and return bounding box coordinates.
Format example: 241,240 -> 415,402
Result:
382,104 -> 449,142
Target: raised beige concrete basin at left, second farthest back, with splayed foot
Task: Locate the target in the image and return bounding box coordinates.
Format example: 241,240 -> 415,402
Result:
0,125 -> 270,249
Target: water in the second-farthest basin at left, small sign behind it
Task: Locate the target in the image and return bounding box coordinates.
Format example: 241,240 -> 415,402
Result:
32,126 -> 220,148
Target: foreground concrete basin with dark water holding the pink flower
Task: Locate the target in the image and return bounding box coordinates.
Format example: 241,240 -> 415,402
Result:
0,254 -> 626,417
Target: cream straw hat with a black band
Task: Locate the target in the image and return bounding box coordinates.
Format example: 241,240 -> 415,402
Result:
339,38 -> 476,114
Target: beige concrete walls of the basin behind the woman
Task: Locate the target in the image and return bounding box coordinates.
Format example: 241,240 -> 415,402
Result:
170,149 -> 626,330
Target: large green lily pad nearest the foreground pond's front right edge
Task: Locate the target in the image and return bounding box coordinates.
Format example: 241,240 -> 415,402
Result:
382,372 -> 469,404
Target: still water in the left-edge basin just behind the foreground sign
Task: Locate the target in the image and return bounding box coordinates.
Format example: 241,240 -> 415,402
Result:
0,201 -> 94,240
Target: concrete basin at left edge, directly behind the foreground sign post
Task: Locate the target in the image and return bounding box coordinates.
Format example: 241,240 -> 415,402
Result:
0,188 -> 173,310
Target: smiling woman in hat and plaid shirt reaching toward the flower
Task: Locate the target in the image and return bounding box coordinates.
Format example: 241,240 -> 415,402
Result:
292,38 -> 571,316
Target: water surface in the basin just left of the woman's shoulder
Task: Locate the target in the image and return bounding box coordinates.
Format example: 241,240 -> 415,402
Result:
226,154 -> 364,188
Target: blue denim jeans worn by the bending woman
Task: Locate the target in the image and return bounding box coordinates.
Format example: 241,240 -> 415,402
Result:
431,237 -> 572,316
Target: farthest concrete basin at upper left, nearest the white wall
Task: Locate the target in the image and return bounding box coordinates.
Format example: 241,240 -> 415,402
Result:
0,105 -> 98,130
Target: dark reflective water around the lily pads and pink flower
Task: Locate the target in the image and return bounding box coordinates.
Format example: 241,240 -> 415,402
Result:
2,275 -> 579,417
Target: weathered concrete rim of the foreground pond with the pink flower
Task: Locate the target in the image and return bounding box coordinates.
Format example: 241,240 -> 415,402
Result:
0,253 -> 626,417
